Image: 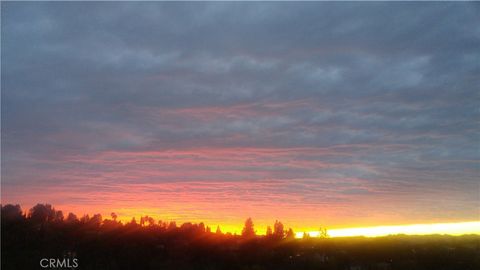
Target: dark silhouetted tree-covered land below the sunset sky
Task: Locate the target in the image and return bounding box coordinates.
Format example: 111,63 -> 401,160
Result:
1,205 -> 480,270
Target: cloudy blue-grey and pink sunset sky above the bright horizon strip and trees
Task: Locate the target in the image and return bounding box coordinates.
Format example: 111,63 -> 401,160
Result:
1,2 -> 480,234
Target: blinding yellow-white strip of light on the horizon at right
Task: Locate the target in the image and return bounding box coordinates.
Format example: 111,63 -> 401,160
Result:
295,221 -> 480,238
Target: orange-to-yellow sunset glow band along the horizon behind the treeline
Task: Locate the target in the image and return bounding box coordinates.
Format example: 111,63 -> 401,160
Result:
12,200 -> 480,238
